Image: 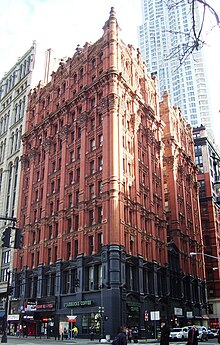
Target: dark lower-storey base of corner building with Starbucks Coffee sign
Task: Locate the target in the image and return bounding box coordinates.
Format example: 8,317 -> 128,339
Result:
12,245 -> 207,337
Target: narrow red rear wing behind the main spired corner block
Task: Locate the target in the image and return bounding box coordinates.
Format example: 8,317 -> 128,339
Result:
160,93 -> 207,324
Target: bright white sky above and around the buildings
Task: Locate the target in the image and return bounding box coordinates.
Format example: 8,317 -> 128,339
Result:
0,0 -> 220,147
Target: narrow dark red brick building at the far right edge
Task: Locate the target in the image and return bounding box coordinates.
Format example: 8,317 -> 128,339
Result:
193,125 -> 220,328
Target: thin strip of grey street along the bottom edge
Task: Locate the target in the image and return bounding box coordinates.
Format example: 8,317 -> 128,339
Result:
2,336 -> 218,345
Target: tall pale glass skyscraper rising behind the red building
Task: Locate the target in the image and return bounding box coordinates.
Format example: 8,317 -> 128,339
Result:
139,0 -> 213,134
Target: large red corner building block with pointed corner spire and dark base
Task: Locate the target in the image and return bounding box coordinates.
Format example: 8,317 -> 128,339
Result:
13,8 -> 208,335
